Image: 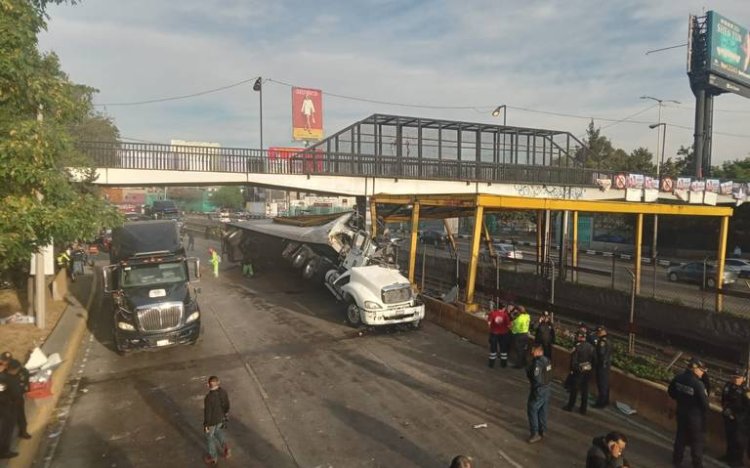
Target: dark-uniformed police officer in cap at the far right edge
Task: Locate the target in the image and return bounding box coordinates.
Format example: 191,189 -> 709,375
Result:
721,369 -> 750,467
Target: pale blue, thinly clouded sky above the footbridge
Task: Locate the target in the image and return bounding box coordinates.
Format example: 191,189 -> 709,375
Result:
40,0 -> 750,165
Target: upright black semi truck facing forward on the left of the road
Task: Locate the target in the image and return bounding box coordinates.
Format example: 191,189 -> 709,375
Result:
103,220 -> 201,354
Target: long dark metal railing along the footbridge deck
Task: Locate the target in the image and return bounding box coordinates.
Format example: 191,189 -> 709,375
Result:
80,142 -> 607,186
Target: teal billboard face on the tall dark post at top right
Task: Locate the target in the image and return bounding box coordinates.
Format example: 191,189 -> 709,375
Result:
707,11 -> 750,87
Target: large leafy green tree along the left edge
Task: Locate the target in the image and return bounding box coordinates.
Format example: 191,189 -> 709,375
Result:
0,0 -> 119,271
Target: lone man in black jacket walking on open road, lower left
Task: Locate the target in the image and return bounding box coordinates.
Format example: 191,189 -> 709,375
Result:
203,375 -> 231,465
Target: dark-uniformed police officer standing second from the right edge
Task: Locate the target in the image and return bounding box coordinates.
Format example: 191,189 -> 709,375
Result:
668,358 -> 708,468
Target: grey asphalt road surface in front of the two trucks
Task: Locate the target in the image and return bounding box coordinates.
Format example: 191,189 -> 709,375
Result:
36,240 -> 718,468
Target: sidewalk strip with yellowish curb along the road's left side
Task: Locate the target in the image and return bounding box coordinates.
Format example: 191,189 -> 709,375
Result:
0,273 -> 97,468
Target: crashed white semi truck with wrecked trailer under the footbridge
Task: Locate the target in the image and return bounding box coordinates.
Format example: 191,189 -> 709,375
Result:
228,212 -> 424,328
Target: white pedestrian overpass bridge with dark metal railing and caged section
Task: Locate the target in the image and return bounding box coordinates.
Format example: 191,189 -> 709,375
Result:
81,114 -> 732,203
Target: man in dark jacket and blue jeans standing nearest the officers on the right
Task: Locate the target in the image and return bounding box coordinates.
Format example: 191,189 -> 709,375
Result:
526,344 -> 552,444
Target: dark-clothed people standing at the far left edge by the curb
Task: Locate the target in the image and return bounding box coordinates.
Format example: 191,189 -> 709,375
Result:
0,351 -> 31,459
